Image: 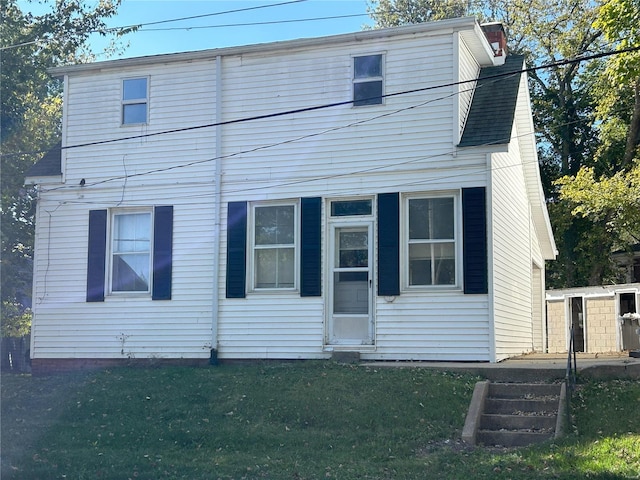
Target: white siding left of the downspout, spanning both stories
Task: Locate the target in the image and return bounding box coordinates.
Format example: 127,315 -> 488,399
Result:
32,61 -> 216,359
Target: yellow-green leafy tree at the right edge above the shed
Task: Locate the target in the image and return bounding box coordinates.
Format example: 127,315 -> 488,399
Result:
555,0 -> 640,284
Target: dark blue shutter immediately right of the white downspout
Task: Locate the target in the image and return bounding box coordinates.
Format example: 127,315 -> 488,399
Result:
226,202 -> 247,298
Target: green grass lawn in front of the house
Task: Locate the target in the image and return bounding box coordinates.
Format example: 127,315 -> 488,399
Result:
1,362 -> 640,480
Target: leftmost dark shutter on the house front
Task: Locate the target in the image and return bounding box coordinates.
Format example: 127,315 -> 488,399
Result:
87,210 -> 107,302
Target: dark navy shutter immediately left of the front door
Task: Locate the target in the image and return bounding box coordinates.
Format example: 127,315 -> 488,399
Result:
300,197 -> 322,297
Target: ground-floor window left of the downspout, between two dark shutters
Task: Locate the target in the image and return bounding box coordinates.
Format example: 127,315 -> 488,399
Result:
111,212 -> 152,293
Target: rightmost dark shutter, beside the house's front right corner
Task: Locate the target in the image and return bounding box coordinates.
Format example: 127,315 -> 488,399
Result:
462,187 -> 489,294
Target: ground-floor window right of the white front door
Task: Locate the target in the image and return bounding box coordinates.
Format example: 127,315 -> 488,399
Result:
407,196 -> 458,287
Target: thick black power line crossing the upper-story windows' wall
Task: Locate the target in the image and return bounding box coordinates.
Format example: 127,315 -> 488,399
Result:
1,46 -> 640,157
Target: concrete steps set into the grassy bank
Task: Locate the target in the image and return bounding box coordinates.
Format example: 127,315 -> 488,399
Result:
462,380 -> 566,447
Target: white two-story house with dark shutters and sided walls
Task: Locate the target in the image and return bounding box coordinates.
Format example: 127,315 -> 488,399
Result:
27,18 -> 555,372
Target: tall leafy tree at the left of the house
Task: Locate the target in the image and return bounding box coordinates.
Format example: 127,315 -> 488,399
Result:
0,0 -> 131,331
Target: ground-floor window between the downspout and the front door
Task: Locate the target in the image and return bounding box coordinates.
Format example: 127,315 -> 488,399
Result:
252,204 -> 297,290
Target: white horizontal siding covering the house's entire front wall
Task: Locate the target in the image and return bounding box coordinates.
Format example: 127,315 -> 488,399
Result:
32,23 -> 552,361
